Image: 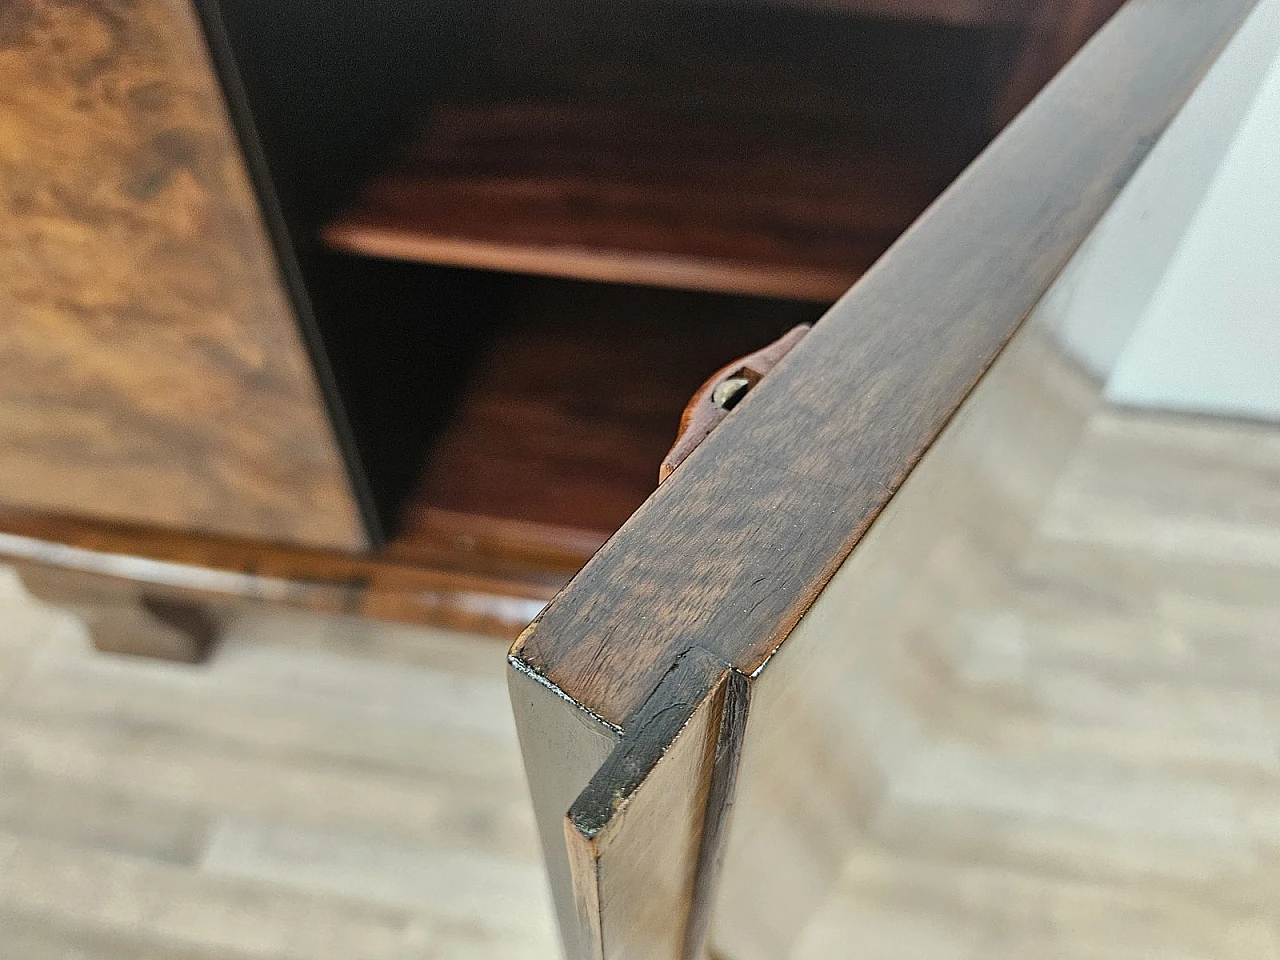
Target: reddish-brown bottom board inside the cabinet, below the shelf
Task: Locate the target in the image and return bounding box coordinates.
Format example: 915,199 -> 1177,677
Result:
393,279 -> 819,560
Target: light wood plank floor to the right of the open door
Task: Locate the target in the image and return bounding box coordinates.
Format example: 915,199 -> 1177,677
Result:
795,410 -> 1280,960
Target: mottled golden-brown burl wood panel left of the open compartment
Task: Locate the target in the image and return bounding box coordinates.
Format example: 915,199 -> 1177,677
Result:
0,0 -> 366,548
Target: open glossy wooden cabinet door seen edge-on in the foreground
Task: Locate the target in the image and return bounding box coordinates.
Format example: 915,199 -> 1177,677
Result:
509,0 -> 1280,960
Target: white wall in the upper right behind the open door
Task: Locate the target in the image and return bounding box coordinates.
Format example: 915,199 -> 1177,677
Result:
1100,0 -> 1280,420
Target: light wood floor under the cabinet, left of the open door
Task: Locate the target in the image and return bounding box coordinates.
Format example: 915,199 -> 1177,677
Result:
0,571 -> 556,960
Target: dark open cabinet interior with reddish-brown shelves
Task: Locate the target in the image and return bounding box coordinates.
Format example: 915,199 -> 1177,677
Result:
201,0 -> 1100,568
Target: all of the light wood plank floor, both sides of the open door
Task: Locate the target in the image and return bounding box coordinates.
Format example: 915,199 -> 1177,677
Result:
0,401 -> 1280,960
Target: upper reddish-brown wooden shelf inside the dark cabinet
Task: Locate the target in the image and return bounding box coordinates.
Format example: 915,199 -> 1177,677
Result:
325,3 -> 998,301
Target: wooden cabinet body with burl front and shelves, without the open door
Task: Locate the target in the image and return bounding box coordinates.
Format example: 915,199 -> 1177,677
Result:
0,0 -> 1119,658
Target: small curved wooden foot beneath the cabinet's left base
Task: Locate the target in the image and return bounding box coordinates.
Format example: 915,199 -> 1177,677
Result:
18,567 -> 219,663
